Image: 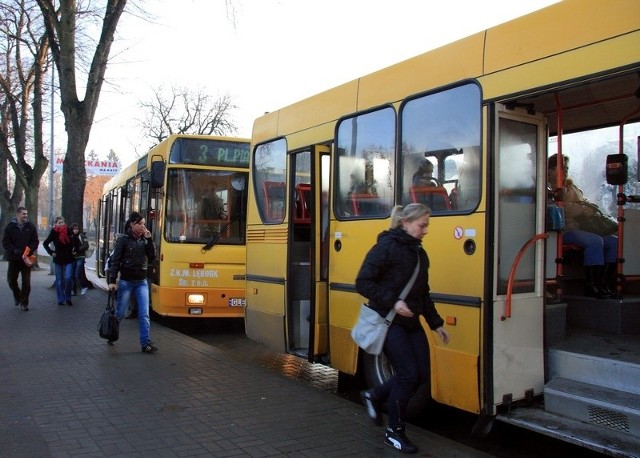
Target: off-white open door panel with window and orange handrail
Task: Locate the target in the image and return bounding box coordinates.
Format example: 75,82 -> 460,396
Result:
492,105 -> 547,405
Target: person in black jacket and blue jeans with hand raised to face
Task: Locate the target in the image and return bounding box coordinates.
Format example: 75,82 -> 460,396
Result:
107,212 -> 158,353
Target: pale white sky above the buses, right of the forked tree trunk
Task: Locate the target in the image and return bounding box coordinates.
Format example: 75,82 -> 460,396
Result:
72,0 -> 555,166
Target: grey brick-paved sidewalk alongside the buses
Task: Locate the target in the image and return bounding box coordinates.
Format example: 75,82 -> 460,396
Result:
0,262 -> 487,457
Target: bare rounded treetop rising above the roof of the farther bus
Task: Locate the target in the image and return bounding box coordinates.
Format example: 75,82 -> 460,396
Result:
140,86 -> 238,144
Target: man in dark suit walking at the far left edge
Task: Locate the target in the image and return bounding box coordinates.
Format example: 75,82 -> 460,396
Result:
2,207 -> 39,312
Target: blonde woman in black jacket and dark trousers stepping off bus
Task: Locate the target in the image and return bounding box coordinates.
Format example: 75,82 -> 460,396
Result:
356,204 -> 449,453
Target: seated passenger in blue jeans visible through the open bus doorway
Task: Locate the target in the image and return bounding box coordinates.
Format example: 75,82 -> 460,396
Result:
547,154 -> 618,298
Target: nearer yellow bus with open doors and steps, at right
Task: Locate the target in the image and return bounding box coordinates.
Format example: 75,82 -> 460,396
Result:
245,0 -> 640,453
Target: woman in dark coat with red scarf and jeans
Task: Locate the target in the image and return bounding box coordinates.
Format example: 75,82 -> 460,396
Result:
42,216 -> 75,305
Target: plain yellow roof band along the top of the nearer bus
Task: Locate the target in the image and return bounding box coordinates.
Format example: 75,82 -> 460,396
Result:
252,0 -> 640,143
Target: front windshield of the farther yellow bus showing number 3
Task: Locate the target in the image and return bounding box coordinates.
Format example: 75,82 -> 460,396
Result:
164,168 -> 248,245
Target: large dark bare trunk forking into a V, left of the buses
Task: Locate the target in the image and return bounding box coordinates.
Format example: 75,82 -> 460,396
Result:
36,0 -> 127,228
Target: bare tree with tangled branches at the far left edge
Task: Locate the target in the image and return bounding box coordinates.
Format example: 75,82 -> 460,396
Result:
0,0 -> 49,247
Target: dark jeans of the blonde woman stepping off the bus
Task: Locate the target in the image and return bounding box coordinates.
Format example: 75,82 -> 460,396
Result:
372,324 -> 430,426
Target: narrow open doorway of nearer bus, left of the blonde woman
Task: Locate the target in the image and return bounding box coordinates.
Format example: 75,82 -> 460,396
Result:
286,145 -> 330,361
